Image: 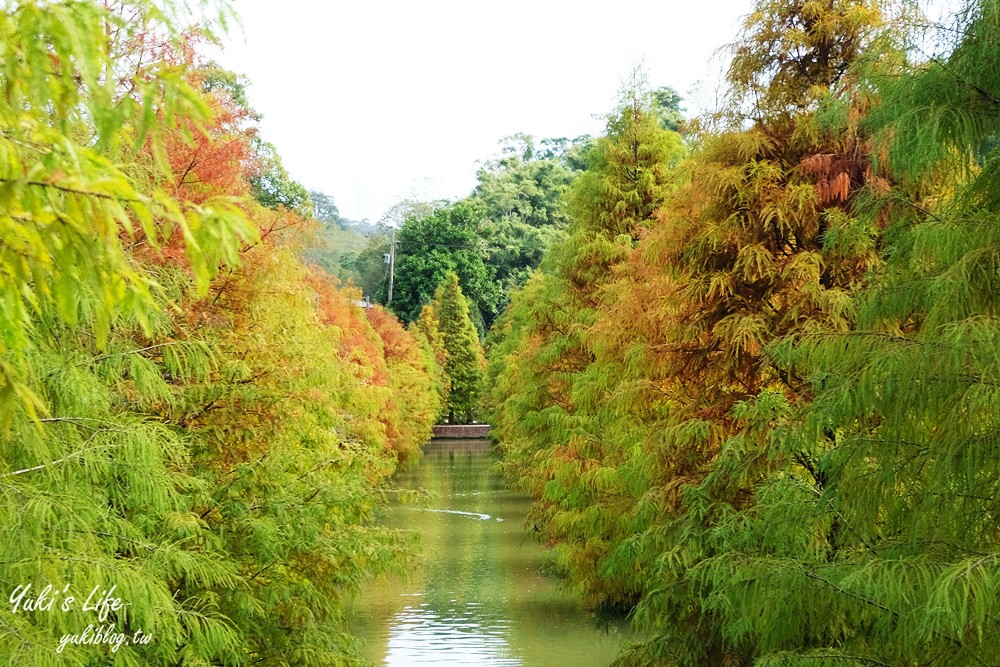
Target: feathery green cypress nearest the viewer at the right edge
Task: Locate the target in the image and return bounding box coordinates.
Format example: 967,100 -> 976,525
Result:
684,0 -> 1000,666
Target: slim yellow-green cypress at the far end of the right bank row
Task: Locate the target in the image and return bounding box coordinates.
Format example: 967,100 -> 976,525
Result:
489,89 -> 683,608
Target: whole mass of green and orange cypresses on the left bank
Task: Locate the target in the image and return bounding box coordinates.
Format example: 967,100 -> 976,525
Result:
0,0 -> 446,667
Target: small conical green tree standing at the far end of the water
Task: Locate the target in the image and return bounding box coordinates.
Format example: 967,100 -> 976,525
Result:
434,273 -> 486,424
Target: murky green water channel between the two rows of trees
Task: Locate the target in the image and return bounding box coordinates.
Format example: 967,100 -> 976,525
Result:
354,440 -> 623,667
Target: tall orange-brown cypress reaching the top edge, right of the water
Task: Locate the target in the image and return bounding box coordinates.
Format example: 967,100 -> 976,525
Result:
599,0 -> 898,665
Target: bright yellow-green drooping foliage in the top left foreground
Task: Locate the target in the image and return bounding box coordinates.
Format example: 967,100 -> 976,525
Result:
0,1 -> 253,428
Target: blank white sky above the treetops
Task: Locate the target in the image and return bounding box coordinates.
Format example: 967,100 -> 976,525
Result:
220,0 -> 751,222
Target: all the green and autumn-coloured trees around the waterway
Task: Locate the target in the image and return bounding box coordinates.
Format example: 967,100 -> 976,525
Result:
0,0 -> 1000,667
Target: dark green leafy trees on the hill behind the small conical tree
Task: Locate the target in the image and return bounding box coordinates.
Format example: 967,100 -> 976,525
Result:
354,134 -> 591,338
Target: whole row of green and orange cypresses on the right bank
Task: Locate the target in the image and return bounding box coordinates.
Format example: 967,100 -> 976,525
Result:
487,0 -> 1000,667
